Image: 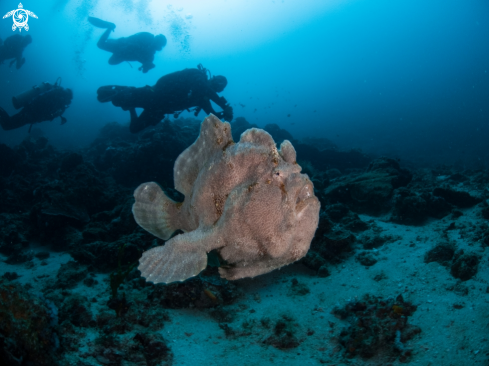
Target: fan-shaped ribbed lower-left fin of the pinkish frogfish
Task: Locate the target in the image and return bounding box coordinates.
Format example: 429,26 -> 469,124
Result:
138,230 -> 209,283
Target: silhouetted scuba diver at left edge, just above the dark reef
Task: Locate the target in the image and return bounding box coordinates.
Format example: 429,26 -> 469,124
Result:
0,78 -> 73,132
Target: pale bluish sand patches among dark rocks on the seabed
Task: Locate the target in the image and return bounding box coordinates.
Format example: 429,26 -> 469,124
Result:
0,204 -> 489,366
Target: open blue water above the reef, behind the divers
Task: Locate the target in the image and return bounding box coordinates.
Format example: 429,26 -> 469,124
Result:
0,0 -> 489,166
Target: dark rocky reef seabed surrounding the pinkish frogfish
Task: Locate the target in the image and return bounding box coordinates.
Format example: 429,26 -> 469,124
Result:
0,118 -> 489,366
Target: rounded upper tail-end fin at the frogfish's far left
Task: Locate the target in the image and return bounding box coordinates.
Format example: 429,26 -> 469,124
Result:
132,182 -> 181,240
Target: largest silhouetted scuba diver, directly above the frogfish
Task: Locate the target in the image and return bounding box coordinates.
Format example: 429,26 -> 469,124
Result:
97,64 -> 233,133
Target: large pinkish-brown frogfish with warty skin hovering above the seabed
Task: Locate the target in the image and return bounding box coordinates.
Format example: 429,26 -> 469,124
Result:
133,115 -> 320,282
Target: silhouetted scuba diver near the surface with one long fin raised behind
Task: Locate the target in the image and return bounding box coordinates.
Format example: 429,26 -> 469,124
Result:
88,17 -> 166,73
